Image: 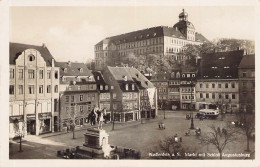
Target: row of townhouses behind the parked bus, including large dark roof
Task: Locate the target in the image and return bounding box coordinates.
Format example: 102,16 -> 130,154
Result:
151,49 -> 255,112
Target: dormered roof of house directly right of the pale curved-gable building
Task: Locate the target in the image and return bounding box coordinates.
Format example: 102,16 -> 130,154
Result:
56,62 -> 93,76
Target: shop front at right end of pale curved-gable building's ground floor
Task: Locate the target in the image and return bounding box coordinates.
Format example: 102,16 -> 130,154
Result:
38,112 -> 52,134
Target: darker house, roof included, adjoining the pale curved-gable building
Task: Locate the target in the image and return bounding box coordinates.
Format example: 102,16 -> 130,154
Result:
57,62 -> 99,130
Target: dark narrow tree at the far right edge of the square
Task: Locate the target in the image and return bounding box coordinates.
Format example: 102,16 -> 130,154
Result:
237,112 -> 255,152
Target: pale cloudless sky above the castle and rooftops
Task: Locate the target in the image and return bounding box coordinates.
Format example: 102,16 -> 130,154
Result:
9,6 -> 255,62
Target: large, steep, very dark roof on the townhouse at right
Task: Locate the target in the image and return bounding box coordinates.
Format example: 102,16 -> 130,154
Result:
198,50 -> 244,79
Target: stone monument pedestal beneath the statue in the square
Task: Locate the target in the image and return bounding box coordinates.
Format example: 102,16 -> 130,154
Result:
77,128 -> 113,159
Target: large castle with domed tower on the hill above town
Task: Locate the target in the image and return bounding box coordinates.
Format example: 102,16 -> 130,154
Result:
95,9 -> 209,70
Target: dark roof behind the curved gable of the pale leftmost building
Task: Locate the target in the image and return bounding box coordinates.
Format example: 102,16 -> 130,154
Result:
9,42 -> 56,66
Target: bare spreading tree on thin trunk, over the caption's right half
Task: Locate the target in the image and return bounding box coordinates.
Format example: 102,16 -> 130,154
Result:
200,125 -> 236,159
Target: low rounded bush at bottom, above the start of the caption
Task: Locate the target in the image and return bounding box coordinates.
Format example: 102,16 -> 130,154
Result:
150,136 -> 198,159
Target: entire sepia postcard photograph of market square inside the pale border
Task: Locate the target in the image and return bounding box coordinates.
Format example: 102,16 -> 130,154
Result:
0,1 -> 257,166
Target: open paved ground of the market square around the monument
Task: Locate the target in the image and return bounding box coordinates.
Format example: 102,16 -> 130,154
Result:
10,111 -> 254,159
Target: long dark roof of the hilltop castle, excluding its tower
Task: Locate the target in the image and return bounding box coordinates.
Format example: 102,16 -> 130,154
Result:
96,26 -> 208,45
